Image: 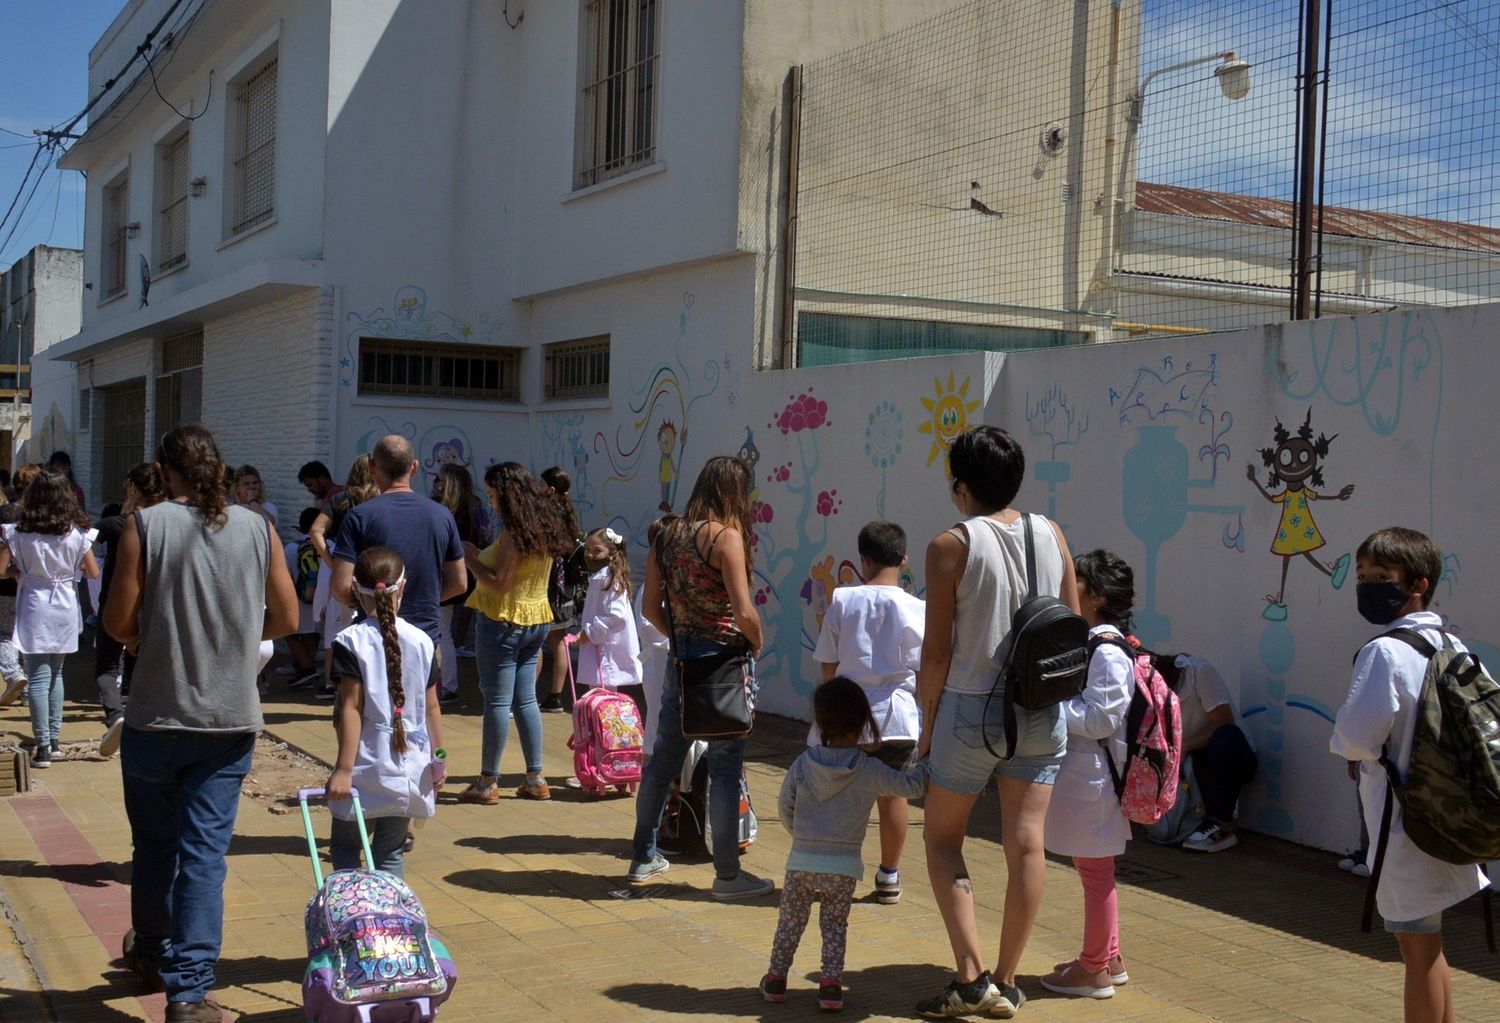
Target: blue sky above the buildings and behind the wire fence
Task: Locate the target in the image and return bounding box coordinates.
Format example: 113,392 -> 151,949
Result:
0,0 -> 1500,267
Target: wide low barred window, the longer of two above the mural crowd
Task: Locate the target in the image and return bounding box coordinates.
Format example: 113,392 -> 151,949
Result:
360,338 -> 521,402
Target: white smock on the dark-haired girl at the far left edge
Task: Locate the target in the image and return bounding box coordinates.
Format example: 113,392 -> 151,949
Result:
0,525 -> 92,654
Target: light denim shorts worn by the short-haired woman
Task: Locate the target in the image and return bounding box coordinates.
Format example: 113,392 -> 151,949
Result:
929,690 -> 1068,795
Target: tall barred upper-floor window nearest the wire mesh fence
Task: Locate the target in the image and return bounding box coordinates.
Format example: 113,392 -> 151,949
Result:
578,0 -> 662,188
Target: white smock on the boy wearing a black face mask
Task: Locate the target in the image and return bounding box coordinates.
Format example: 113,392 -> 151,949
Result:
1329,611 -> 1485,921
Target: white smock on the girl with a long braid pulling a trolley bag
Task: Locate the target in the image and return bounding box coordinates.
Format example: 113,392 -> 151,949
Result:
329,618 -> 435,821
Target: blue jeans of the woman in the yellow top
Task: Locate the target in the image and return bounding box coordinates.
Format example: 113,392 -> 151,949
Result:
474,615 -> 552,779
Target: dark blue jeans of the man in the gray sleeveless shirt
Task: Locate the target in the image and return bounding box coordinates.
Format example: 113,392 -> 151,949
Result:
120,728 -> 255,1002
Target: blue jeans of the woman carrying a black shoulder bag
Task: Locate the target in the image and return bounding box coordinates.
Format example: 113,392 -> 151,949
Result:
632,642 -> 746,881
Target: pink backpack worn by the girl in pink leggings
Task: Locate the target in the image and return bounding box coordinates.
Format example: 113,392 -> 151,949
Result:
1089,636 -> 1182,824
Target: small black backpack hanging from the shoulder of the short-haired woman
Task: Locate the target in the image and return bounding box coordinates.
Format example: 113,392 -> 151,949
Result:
981,515 -> 1089,761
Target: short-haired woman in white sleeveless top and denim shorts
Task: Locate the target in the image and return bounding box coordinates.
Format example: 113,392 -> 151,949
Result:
917,426 -> 1079,1019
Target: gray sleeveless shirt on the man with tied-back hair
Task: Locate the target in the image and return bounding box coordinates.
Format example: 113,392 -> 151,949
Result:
125,501 -> 272,732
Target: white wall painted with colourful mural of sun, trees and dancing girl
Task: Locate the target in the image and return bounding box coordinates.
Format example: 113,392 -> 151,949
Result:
339,260 -> 1500,849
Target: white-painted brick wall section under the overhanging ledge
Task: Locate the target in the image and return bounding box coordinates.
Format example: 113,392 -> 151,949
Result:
203,290 -> 328,536
